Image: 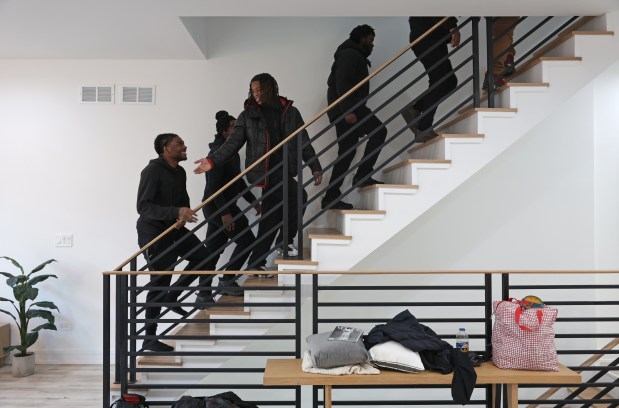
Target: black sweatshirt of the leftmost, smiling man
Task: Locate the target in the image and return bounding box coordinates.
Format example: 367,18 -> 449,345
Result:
137,157 -> 189,235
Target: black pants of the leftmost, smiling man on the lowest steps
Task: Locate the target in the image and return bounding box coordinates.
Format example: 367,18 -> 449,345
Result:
138,227 -> 213,335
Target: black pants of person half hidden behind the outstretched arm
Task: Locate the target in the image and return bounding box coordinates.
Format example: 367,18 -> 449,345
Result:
200,205 -> 256,276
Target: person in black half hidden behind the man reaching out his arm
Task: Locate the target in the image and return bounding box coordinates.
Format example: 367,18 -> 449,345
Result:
200,111 -> 261,296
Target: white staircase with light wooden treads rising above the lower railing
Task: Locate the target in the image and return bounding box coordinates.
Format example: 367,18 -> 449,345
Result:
277,15 -> 619,283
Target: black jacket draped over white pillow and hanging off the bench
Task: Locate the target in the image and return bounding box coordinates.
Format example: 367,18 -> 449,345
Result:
364,310 -> 477,404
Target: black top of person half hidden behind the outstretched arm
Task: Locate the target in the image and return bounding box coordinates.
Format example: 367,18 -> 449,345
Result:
202,135 -> 256,216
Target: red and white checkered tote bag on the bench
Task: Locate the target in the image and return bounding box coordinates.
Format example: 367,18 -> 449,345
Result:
492,299 -> 559,371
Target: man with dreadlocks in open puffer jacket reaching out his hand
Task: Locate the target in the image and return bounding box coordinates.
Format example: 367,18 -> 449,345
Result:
194,73 -> 322,277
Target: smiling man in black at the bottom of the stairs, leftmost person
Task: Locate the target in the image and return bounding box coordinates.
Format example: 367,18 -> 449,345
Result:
137,133 -> 212,351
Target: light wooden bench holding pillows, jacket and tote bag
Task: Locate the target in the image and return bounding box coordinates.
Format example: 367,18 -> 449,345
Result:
263,359 -> 581,408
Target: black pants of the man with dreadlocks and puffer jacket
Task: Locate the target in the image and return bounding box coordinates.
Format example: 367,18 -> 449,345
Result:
248,174 -> 307,269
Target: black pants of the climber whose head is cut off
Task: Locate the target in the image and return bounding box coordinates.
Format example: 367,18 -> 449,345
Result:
413,44 -> 458,130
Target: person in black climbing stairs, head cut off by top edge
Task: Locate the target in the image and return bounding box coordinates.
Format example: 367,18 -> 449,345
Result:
402,17 -> 460,143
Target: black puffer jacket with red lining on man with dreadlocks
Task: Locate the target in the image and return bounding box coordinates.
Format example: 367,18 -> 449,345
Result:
208,97 -> 322,187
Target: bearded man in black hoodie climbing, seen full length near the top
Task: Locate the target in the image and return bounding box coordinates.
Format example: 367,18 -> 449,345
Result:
321,24 -> 387,210
